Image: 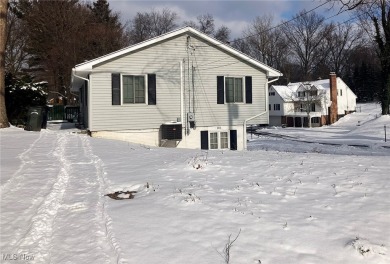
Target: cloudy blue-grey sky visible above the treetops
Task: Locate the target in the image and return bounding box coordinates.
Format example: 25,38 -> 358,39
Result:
108,0 -> 349,38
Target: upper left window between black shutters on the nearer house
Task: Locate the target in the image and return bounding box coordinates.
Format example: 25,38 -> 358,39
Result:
122,75 -> 146,104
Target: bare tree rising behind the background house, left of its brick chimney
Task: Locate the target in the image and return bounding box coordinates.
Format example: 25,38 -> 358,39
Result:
281,10 -> 331,79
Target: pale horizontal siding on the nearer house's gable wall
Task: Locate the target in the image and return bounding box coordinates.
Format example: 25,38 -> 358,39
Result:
89,35 -> 268,131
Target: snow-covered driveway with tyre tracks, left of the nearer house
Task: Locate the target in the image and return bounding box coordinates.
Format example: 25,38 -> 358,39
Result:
0,128 -> 118,263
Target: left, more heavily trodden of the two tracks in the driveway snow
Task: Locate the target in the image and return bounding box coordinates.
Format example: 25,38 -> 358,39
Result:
14,134 -> 71,263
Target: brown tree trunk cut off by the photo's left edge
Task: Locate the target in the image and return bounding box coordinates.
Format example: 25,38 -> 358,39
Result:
0,0 -> 9,128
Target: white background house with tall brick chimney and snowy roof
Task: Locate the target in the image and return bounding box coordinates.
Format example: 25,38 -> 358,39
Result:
268,73 -> 357,127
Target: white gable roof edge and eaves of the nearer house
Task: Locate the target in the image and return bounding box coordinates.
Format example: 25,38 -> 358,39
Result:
72,27 -> 283,86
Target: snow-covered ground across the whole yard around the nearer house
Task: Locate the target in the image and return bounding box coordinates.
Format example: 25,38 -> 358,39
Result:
0,104 -> 390,264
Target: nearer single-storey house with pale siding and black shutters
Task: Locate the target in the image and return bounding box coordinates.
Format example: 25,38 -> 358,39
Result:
72,27 -> 282,150
